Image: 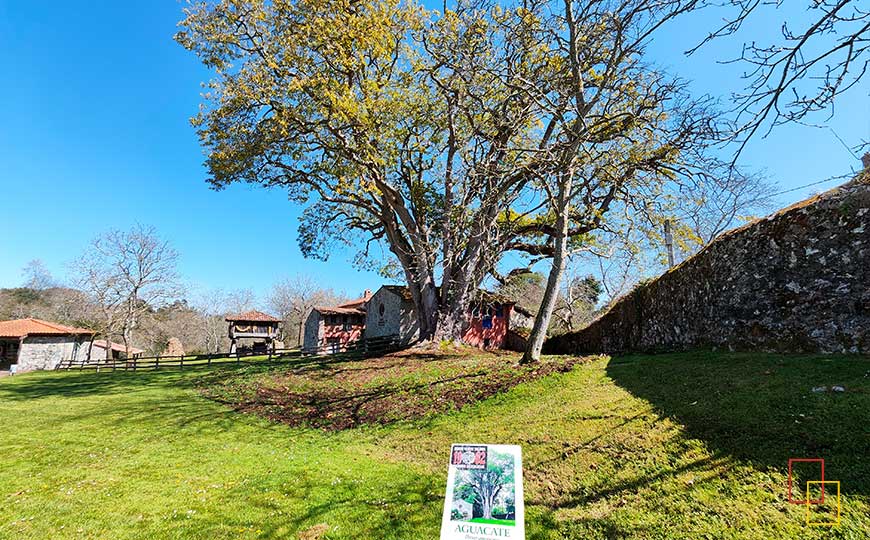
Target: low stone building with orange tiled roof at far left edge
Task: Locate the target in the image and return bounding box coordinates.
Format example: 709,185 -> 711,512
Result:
0,319 -> 94,372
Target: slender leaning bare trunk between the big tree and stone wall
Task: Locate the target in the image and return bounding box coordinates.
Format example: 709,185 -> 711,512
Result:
520,175 -> 573,364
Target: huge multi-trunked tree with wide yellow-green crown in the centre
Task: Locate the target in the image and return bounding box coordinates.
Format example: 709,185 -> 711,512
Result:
176,0 -> 706,339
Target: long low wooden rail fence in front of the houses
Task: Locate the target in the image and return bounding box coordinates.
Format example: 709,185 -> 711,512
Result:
55,336 -> 410,371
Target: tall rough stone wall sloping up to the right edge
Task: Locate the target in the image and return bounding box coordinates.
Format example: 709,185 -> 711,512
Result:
544,172 -> 870,353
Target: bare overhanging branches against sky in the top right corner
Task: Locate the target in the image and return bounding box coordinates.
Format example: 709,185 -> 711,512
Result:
688,0 -> 870,155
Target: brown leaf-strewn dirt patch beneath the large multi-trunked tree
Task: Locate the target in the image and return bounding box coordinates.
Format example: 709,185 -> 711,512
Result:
201,350 -> 586,430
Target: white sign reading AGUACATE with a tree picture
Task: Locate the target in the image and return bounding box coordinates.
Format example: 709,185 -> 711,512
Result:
441,444 -> 526,540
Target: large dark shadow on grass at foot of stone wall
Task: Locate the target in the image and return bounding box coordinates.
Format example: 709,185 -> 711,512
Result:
606,352 -> 870,496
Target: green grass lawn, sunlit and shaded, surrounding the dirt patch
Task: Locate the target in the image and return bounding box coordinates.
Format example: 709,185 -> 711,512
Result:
0,353 -> 870,540
